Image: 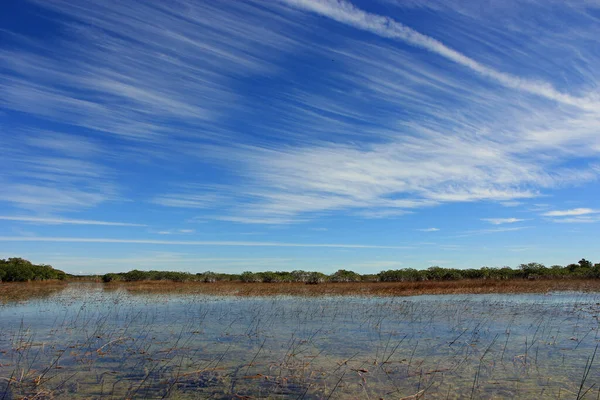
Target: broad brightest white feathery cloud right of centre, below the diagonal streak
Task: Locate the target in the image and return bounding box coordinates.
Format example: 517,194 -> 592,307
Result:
200,126 -> 593,222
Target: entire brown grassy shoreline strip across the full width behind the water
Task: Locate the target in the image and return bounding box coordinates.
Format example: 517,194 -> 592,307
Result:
0,279 -> 600,303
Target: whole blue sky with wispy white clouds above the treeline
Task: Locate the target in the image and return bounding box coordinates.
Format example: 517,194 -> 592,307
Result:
0,0 -> 600,274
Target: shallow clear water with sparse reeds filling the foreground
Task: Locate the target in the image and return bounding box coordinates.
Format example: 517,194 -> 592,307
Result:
0,284 -> 600,399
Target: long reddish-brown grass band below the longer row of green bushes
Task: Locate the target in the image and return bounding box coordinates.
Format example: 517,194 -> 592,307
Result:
105,279 -> 600,296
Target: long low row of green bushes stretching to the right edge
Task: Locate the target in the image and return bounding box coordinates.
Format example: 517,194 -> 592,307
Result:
102,259 -> 600,284
